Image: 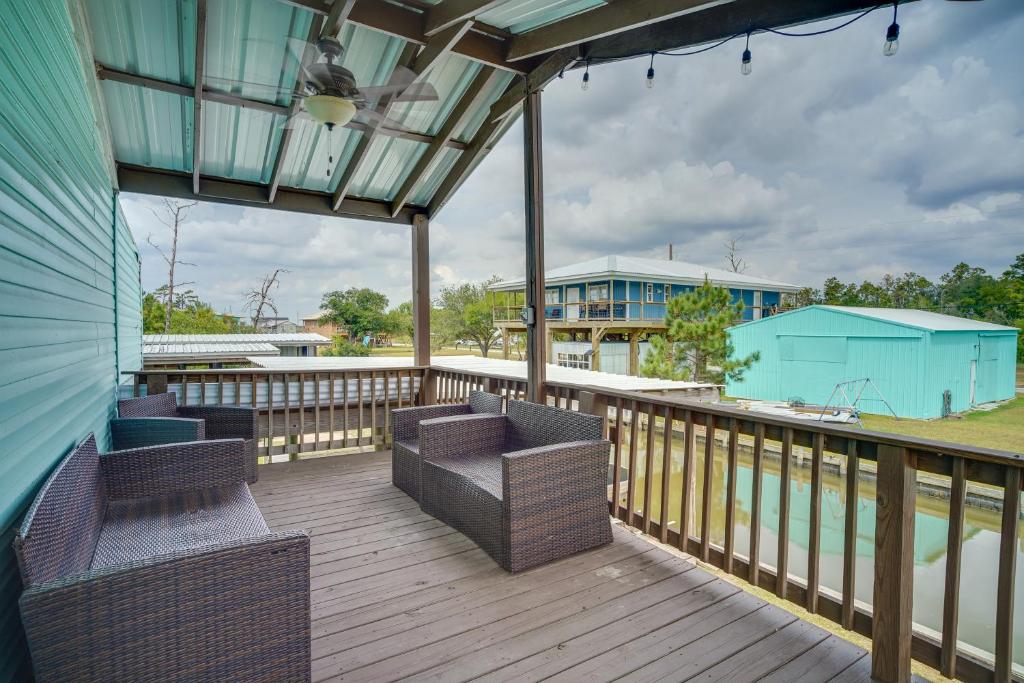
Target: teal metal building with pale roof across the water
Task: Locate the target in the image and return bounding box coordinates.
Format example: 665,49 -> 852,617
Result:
726,306 -> 1019,419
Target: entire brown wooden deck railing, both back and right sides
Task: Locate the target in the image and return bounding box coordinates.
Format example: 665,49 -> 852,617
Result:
133,366 -> 1024,681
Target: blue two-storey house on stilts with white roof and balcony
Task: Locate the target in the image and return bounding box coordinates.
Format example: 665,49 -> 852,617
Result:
488,256 -> 800,375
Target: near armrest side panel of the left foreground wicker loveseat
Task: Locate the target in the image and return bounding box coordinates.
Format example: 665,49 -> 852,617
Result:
20,531 -> 310,681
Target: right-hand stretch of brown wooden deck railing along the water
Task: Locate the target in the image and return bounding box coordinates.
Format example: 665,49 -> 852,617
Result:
442,376 -> 1024,681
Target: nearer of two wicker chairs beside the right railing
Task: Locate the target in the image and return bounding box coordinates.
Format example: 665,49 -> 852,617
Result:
420,400 -> 611,571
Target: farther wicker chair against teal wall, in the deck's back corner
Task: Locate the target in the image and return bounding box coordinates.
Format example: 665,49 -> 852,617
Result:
111,393 -> 259,483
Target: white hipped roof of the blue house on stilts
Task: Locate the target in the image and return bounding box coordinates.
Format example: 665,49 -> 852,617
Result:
490,256 -> 801,292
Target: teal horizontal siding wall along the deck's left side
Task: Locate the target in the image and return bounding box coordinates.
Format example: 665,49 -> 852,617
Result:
0,0 -> 141,681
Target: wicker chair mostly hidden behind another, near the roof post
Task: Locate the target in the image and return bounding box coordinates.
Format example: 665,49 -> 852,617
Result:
391,391 -> 502,502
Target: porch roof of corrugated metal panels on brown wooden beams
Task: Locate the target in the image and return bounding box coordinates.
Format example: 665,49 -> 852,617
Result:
83,0 -> 880,223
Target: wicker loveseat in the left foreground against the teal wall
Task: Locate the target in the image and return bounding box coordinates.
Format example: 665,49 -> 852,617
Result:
14,434 -> 310,681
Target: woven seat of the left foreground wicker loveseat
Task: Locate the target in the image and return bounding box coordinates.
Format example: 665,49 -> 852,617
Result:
91,483 -> 270,569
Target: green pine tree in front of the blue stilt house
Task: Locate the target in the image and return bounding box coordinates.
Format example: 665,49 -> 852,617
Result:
640,279 -> 760,384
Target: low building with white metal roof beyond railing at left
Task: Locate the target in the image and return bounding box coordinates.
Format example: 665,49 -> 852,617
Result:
142,333 -> 331,369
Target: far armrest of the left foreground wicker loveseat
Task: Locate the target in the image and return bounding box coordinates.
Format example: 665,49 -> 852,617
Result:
99,438 -> 246,500
